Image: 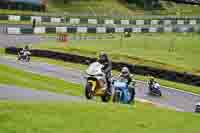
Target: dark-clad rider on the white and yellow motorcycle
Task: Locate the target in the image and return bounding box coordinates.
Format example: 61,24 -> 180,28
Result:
98,52 -> 112,95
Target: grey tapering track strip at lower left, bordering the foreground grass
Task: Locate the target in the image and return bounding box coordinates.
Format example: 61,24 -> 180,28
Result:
0,85 -> 84,102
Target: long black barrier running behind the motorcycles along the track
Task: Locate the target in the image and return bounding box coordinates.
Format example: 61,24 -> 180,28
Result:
6,47 -> 200,86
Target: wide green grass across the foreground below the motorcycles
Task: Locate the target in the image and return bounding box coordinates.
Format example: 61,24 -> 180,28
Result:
0,101 -> 200,133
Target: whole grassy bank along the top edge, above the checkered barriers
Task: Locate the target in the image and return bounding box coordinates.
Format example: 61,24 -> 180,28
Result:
48,0 -> 200,16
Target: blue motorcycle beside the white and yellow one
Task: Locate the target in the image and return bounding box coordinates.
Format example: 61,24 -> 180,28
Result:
113,80 -> 135,104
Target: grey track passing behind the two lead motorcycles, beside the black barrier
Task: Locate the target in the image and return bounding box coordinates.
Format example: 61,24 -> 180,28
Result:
0,57 -> 200,112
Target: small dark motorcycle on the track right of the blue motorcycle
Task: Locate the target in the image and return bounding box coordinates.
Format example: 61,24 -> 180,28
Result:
149,83 -> 162,97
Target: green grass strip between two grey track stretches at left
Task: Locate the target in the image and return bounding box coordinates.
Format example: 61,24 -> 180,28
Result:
0,64 -> 82,96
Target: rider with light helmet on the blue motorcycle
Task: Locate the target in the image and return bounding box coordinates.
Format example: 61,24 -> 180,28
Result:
118,67 -> 135,101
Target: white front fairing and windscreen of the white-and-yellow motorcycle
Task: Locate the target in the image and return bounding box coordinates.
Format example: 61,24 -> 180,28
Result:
86,62 -> 103,75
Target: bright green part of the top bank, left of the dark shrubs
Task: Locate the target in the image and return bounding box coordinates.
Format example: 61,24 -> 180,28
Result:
48,0 -> 139,16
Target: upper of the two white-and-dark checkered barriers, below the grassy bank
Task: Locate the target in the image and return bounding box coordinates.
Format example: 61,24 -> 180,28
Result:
0,15 -> 200,26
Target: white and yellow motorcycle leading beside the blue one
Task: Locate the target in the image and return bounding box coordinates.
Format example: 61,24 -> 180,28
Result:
85,62 -> 111,102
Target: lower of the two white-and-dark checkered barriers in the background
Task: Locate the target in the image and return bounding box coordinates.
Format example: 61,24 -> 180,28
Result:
7,26 -> 200,34
